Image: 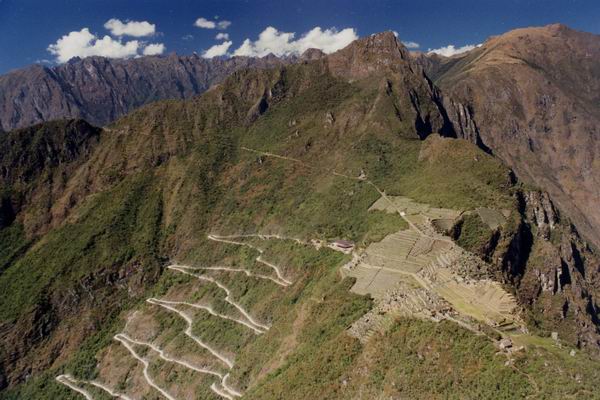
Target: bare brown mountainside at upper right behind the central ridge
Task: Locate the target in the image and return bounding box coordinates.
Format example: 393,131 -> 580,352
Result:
434,25 -> 600,250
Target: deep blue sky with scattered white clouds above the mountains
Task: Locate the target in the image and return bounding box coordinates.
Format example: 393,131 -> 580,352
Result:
0,0 -> 600,74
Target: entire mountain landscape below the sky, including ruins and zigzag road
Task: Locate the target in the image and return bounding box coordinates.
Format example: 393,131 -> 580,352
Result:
0,25 -> 600,399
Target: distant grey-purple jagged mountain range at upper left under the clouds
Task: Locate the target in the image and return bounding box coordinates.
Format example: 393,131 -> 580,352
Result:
0,54 -> 292,131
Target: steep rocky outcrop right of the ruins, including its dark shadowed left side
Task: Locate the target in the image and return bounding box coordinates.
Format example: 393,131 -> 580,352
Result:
481,191 -> 600,352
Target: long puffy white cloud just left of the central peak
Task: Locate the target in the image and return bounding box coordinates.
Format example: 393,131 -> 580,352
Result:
233,26 -> 358,57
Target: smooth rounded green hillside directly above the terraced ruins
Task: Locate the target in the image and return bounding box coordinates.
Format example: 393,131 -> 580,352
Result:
361,135 -> 513,210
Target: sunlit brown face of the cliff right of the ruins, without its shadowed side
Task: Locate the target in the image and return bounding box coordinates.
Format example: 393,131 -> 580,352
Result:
519,192 -> 600,348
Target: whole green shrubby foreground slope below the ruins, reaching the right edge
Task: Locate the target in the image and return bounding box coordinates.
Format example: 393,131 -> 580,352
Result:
246,314 -> 600,399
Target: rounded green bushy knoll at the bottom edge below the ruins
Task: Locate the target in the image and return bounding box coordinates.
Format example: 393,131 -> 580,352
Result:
340,319 -> 531,399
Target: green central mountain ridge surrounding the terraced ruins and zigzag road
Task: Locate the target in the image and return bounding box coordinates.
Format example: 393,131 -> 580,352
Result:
0,33 -> 600,399
